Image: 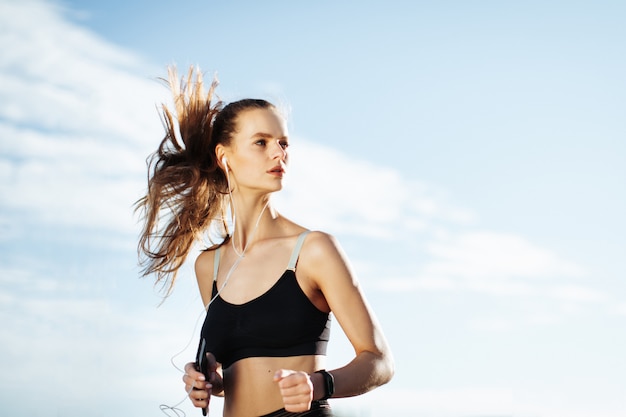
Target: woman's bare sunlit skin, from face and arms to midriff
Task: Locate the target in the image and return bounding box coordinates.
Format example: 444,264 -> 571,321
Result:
183,109 -> 393,417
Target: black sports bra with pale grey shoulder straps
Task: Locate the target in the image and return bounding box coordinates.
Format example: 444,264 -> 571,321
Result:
200,231 -> 330,369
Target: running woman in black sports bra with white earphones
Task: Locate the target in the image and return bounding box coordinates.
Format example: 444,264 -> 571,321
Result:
139,68 -> 393,417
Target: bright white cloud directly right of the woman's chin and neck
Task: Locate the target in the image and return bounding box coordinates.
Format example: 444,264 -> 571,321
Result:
276,138 -> 474,240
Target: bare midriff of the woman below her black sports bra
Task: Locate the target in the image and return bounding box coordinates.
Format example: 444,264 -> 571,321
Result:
224,355 -> 326,417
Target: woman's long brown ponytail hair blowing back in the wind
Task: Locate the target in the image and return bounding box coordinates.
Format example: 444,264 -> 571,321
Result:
135,66 -> 274,296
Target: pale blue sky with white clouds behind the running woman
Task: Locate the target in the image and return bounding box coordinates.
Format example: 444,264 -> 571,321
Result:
0,0 -> 626,417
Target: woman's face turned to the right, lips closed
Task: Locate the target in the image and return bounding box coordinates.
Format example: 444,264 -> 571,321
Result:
224,109 -> 289,192
